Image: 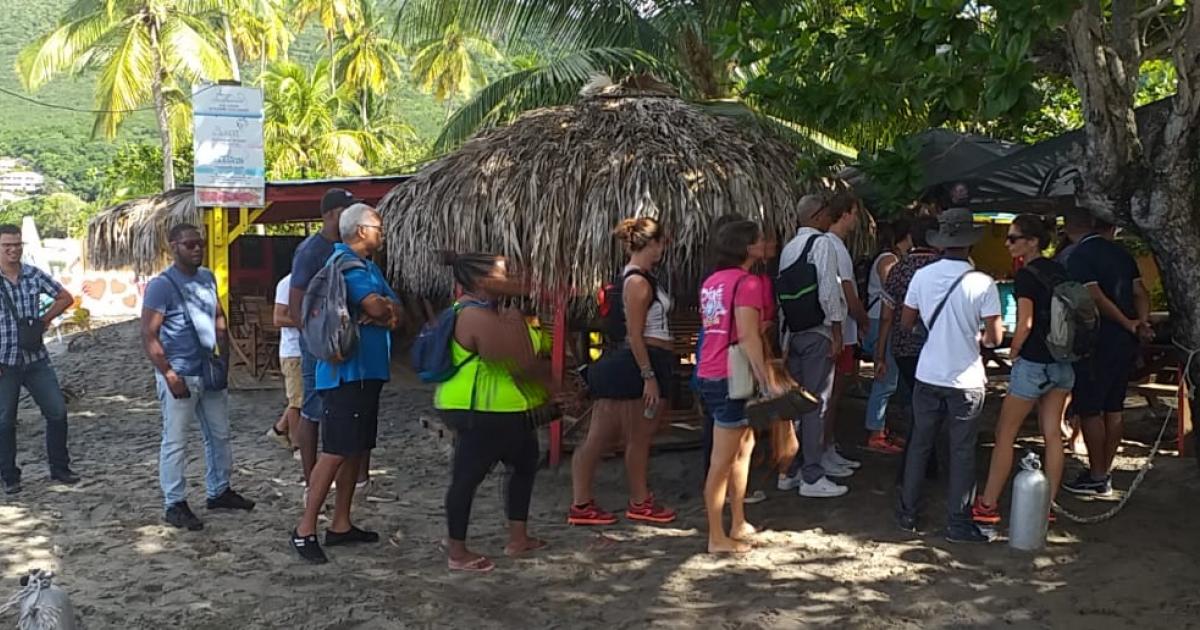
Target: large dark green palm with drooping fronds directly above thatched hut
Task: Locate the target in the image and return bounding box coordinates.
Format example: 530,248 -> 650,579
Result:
397,0 -> 853,155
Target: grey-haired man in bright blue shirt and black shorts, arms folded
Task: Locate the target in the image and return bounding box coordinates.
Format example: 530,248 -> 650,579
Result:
292,204 -> 401,563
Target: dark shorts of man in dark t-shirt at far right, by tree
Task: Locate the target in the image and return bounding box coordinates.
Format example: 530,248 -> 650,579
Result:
1070,334 -> 1139,418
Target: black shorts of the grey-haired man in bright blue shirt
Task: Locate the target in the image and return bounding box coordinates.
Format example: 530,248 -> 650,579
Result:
320,380 -> 383,457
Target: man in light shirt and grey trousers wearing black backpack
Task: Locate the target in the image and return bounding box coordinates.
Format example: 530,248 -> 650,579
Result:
778,194 -> 853,498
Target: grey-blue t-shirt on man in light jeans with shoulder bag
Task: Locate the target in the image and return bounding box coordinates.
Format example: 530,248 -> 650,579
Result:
142,265 -> 217,377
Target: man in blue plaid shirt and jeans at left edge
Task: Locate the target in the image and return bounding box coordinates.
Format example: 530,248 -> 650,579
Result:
0,224 -> 79,494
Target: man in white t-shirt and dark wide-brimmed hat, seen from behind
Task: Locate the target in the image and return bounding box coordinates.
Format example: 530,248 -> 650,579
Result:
896,208 -> 1004,542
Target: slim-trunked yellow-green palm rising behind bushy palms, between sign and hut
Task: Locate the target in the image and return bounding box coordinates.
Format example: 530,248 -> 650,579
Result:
334,0 -> 404,127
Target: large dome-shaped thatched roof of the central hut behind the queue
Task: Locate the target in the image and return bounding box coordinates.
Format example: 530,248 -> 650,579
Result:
379,77 -> 820,307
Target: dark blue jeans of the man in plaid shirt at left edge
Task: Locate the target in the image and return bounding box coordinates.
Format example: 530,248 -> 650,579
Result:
0,359 -> 71,481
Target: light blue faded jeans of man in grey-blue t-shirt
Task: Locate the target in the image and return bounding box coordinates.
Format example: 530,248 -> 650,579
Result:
155,372 -> 233,508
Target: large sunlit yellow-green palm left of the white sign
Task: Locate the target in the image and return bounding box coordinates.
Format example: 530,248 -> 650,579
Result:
17,0 -> 230,190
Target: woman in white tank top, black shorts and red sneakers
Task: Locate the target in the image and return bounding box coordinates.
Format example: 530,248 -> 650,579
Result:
566,217 -> 677,526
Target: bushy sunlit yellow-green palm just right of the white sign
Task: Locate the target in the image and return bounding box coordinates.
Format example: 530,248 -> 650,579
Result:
262,60 -> 367,178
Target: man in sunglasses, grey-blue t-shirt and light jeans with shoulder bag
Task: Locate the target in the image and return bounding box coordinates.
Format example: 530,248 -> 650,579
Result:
142,224 -> 254,532
